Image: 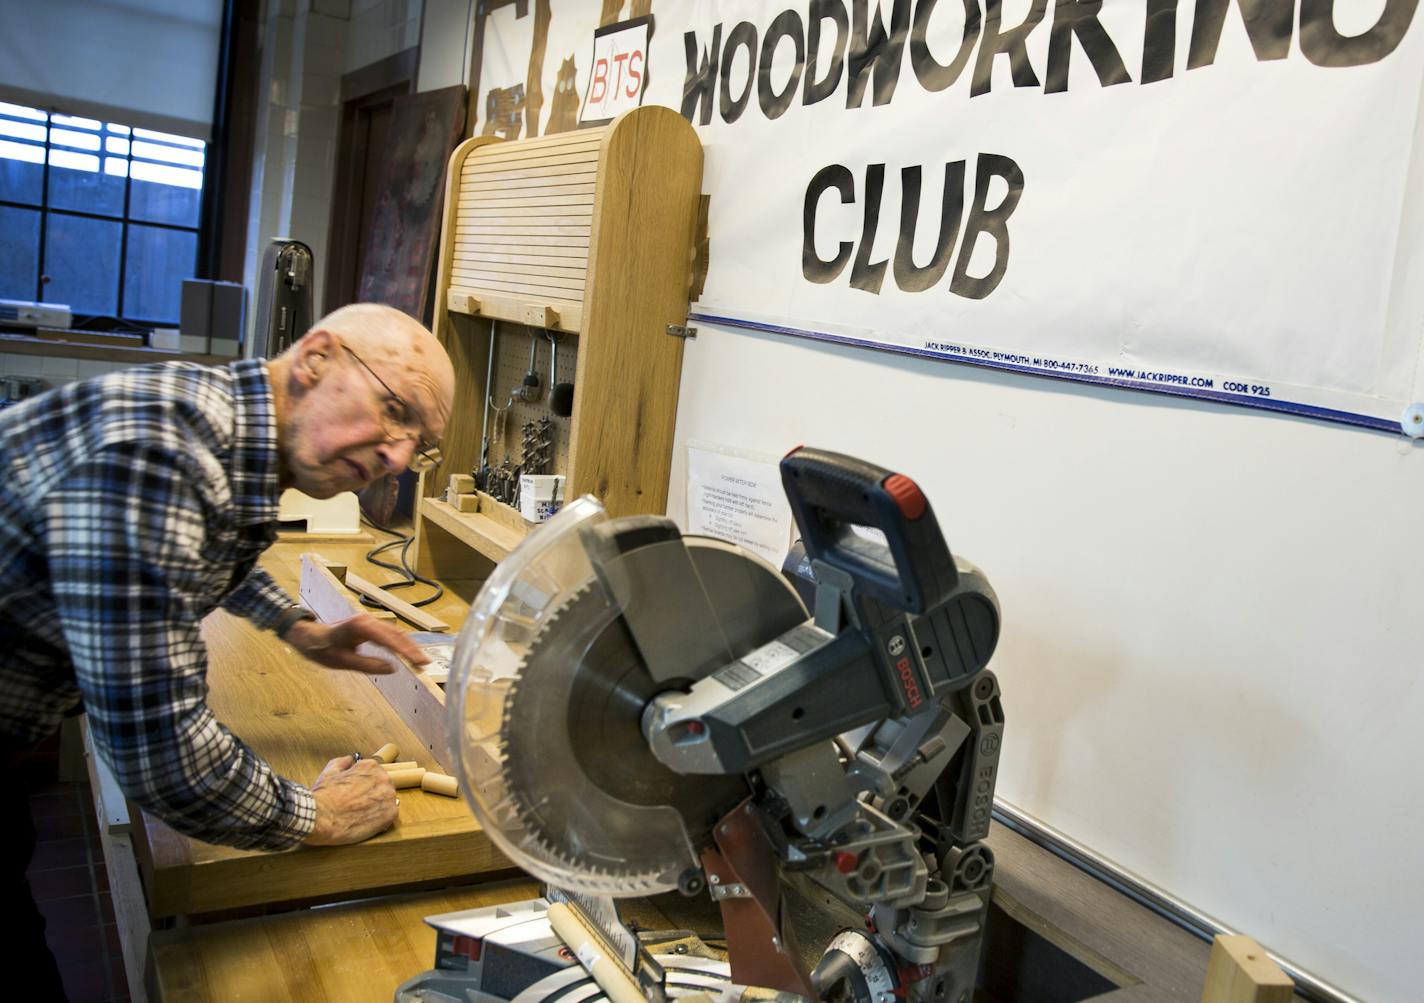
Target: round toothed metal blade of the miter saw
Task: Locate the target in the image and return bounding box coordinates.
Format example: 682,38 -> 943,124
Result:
500,537 -> 806,893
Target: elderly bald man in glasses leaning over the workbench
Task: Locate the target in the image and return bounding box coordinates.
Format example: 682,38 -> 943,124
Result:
0,303 -> 454,997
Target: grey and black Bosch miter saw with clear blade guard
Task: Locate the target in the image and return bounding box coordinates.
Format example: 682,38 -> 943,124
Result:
397,449 -> 1004,1003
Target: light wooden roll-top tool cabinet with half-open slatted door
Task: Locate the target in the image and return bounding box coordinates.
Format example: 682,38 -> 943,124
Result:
416,107 -> 702,577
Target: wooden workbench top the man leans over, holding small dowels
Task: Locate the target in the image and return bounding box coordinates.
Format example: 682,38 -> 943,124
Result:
135,543 -> 510,918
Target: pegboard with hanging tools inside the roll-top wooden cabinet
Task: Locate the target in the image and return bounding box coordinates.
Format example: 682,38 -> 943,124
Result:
488,321 -> 578,474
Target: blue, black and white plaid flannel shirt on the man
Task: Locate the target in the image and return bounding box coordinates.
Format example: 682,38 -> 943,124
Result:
0,360 -> 316,849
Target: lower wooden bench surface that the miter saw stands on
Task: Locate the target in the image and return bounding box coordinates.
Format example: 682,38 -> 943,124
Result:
150,822 -> 1287,1003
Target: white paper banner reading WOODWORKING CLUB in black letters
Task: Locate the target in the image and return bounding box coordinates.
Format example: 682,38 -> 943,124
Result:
480,0 -> 1424,435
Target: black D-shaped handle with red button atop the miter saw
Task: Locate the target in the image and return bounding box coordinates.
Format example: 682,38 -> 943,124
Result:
782,446 -> 958,613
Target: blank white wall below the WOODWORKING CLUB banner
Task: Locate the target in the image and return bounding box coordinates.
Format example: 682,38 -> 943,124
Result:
669,325 -> 1424,1000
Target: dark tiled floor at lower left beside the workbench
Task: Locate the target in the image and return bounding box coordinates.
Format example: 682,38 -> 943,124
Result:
26,745 -> 128,1003
